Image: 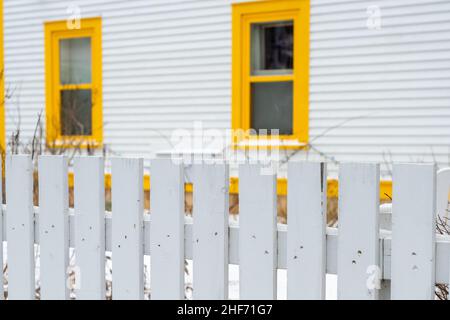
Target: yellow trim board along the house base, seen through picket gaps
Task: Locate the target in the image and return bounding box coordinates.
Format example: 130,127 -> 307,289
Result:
69,172 -> 394,200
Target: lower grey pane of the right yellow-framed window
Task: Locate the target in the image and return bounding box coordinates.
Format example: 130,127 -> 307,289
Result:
251,81 -> 293,135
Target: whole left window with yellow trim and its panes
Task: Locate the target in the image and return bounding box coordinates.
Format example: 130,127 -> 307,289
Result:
45,18 -> 103,147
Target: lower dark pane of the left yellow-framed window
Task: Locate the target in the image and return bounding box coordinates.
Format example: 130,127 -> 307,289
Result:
61,90 -> 92,136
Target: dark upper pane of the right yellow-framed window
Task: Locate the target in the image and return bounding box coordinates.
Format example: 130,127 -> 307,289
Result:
251,21 -> 294,75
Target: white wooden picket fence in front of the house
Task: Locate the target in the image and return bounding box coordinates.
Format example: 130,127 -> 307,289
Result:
0,155 -> 450,299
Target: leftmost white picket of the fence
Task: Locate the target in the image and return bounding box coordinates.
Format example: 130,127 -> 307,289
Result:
6,155 -> 35,300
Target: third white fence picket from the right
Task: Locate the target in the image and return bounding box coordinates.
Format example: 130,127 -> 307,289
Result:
286,162 -> 327,300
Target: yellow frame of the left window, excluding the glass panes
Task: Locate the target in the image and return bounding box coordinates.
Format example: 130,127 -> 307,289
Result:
45,18 -> 103,148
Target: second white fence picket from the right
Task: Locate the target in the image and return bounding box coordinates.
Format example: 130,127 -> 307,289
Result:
337,163 -> 381,300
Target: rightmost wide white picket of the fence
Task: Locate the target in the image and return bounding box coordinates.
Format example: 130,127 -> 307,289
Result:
391,164 -> 436,300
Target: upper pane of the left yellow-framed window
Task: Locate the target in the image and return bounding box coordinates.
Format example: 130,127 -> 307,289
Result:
59,38 -> 91,84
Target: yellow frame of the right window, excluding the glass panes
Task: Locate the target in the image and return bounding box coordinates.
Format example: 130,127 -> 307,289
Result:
232,0 -> 310,149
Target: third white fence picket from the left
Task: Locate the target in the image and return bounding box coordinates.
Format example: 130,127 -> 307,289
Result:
74,157 -> 106,300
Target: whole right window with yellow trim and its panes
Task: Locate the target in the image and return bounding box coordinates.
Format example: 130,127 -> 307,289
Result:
232,0 -> 309,148
